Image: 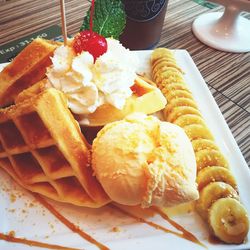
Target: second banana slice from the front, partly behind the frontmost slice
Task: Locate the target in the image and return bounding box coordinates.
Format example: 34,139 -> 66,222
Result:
195,182 -> 239,220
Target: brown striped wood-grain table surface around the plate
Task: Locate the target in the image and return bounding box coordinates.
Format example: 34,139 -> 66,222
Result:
0,0 -> 250,168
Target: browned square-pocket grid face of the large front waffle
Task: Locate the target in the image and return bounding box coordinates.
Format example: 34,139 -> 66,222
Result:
0,90 -> 109,207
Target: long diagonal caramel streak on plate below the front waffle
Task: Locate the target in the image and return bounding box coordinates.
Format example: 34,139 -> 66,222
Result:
33,193 -> 109,250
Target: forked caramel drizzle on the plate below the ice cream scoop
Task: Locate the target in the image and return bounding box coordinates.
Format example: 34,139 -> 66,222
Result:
109,204 -> 207,248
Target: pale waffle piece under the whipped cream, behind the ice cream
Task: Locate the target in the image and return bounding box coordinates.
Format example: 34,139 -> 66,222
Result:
76,76 -> 166,126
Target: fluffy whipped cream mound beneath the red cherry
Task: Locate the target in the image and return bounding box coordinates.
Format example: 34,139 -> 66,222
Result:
47,38 -> 138,119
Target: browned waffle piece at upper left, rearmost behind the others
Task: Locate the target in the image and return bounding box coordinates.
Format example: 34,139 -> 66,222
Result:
0,38 -> 58,107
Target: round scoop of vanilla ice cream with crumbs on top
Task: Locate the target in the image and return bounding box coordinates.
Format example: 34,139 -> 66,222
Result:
92,113 -> 199,207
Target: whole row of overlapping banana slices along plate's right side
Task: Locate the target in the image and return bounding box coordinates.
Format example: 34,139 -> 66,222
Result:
151,48 -> 249,244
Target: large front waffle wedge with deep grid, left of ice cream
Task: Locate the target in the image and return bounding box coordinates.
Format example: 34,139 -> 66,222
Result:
0,88 -> 109,207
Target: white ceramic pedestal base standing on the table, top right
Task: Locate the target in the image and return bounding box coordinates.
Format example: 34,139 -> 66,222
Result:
192,0 -> 250,53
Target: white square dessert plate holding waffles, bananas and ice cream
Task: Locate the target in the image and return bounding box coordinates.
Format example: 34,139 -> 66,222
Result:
0,50 -> 250,250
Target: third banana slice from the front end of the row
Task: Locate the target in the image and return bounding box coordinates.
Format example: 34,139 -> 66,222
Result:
196,166 -> 238,192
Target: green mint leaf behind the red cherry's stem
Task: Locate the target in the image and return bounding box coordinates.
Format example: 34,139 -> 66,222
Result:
80,0 -> 126,39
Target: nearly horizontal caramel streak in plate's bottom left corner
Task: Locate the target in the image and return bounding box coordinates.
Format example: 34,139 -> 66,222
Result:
0,233 -> 80,250
